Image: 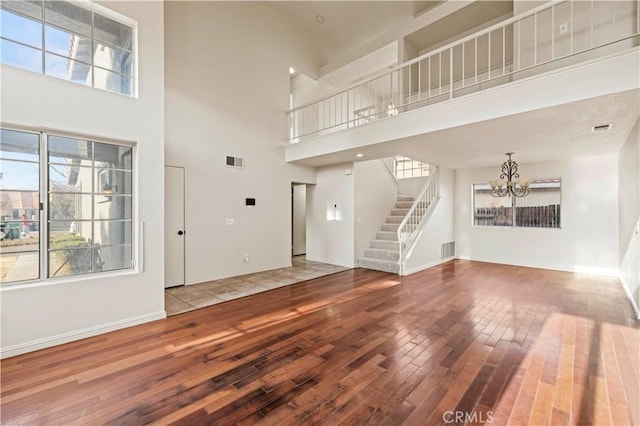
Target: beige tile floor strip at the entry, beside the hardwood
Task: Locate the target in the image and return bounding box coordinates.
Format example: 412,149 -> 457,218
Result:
164,256 -> 349,315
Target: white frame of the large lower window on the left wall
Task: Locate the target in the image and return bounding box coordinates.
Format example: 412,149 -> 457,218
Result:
0,123 -> 140,290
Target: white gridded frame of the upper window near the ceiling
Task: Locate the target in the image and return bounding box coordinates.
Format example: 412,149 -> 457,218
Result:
0,0 -> 139,98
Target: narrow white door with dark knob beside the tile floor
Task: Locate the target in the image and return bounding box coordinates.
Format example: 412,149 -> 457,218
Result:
164,166 -> 186,288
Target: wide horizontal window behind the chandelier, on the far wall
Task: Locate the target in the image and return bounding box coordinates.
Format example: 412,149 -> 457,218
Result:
473,179 -> 560,228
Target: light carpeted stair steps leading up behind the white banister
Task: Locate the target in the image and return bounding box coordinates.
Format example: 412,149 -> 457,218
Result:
358,195 -> 413,274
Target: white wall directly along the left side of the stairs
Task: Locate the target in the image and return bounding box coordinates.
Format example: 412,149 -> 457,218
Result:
354,159 -> 398,264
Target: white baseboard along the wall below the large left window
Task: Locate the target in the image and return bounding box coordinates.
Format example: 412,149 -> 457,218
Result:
0,311 -> 167,359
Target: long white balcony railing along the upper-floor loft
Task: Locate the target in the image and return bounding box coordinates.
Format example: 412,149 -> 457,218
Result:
288,0 -> 640,143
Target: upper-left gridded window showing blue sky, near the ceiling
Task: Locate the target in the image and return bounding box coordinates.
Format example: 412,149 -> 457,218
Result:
0,0 -> 135,96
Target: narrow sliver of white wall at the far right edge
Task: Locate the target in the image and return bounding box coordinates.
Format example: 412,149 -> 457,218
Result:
618,119 -> 640,318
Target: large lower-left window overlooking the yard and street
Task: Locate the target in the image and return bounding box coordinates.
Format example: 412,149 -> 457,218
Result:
0,129 -> 133,283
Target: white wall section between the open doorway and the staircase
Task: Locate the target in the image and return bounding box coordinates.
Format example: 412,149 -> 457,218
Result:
307,163 -> 354,268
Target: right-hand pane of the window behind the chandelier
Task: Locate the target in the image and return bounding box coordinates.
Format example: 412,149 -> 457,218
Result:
516,179 -> 560,228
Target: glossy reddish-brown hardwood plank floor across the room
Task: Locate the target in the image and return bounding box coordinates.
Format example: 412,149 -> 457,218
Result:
0,261 -> 640,425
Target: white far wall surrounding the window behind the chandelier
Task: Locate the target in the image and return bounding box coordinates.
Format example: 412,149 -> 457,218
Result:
455,155 -> 619,275
